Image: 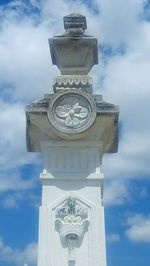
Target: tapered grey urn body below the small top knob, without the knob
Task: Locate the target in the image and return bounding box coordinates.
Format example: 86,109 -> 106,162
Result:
49,36 -> 98,75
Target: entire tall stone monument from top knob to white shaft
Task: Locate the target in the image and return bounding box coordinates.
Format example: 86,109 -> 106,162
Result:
26,14 -> 119,266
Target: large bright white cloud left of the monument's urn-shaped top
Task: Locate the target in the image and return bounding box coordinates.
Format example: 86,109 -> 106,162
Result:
0,17 -> 55,101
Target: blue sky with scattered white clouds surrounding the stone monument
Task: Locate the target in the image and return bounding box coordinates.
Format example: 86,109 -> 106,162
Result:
0,0 -> 150,266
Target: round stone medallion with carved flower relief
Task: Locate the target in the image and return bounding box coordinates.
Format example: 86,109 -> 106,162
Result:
47,89 -> 96,138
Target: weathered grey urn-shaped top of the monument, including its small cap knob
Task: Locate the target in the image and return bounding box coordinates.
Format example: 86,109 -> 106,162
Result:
49,14 -> 98,75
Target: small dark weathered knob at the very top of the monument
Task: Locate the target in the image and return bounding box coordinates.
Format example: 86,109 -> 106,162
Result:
64,13 -> 87,31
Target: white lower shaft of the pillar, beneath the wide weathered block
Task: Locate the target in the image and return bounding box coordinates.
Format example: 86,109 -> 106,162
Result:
38,141 -> 106,266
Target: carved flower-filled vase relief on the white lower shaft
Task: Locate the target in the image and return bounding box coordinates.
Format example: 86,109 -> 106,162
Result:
55,197 -> 89,261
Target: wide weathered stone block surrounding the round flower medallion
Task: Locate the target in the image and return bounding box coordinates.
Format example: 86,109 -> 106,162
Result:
26,93 -> 119,152
